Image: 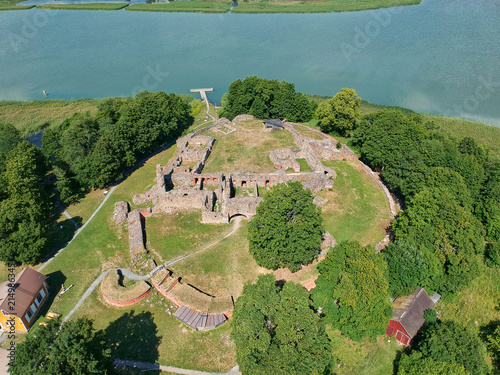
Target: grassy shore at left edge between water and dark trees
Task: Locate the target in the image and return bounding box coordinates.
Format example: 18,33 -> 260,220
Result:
0,99 -> 99,135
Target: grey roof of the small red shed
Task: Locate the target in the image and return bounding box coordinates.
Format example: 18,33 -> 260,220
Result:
392,288 -> 436,338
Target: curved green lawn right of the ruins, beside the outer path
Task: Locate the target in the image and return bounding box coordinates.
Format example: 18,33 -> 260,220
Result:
318,161 -> 390,245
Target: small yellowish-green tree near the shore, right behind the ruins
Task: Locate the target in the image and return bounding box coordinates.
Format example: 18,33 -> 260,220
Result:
316,88 -> 361,136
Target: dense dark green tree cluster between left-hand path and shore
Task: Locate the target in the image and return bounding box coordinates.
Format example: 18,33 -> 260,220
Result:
42,91 -> 190,197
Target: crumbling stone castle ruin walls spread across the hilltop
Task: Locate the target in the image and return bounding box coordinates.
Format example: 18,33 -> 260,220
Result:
130,115 -> 344,228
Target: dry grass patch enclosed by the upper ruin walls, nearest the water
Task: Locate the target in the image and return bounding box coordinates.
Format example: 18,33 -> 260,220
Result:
203,120 -> 297,173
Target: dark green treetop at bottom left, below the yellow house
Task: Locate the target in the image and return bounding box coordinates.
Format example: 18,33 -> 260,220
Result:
10,319 -> 113,375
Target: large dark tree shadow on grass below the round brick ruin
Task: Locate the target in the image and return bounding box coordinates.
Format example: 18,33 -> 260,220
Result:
105,310 -> 162,366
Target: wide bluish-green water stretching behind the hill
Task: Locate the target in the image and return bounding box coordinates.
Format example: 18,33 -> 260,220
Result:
0,0 -> 500,126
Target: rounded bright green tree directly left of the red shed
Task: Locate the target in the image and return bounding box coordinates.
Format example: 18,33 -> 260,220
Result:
311,242 -> 392,341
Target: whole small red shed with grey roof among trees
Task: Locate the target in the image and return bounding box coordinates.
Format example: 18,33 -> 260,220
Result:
385,288 -> 440,346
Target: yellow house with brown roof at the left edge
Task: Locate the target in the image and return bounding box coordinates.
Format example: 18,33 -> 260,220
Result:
0,267 -> 49,332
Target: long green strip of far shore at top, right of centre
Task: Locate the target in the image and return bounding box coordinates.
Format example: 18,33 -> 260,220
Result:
232,0 -> 421,13
